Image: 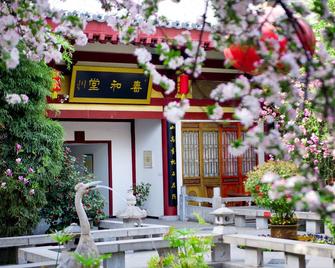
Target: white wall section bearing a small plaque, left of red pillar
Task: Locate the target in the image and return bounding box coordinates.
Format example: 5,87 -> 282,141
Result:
135,119 -> 164,217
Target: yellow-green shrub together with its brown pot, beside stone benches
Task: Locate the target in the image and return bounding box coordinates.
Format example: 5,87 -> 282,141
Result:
245,161 -> 298,239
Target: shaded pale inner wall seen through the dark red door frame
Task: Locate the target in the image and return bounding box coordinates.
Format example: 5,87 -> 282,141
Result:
68,143 -> 109,215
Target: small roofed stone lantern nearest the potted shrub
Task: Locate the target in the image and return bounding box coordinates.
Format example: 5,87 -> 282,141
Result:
210,206 -> 236,234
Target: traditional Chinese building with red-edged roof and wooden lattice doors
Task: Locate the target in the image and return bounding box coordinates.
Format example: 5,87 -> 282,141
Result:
49,16 -> 264,217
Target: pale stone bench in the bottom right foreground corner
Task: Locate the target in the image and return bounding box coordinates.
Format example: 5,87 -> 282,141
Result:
223,234 -> 335,268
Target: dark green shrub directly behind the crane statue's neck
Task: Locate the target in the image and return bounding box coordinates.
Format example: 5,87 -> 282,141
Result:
42,147 -> 105,230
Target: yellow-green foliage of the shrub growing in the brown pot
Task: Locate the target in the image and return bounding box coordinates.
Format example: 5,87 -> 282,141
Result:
245,161 -> 298,225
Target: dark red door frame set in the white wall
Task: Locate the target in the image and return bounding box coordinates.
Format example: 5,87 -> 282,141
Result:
64,138 -> 113,216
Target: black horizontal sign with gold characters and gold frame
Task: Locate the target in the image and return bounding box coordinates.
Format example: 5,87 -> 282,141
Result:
70,66 -> 151,104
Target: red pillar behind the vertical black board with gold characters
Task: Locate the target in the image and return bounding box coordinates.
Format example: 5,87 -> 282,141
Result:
162,119 -> 178,216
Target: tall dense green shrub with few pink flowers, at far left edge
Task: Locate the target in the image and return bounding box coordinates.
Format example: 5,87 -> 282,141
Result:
0,56 -> 63,236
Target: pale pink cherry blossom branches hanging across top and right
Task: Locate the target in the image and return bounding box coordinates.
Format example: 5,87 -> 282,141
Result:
0,0 -> 335,227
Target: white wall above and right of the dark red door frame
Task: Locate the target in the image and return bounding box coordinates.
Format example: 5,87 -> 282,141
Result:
60,121 -> 132,215
